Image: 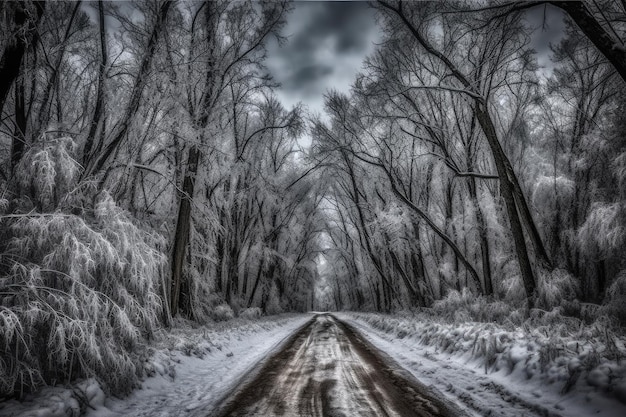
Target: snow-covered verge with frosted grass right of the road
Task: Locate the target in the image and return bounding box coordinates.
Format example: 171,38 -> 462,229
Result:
336,313 -> 626,417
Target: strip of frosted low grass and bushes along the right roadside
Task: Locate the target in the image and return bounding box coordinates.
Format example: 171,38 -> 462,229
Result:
342,310 -> 626,401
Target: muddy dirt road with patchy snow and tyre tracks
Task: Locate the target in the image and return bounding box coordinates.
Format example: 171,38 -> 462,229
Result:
217,314 -> 461,417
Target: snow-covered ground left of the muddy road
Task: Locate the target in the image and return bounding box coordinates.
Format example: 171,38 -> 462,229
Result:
0,314 -> 312,417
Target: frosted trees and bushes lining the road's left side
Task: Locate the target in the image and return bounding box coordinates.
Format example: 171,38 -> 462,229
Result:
0,0 -> 320,398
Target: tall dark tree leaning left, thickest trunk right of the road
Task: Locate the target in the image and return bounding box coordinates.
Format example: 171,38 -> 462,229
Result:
372,1 -> 544,305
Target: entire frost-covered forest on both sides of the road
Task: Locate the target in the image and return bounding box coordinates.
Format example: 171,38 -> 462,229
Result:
0,0 -> 626,406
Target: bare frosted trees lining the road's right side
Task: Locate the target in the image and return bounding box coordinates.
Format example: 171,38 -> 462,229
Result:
312,1 -> 626,323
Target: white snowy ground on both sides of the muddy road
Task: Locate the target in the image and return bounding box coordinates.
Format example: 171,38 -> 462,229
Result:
6,313 -> 626,417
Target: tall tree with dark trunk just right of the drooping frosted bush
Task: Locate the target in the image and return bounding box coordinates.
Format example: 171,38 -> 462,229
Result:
170,1 -> 287,314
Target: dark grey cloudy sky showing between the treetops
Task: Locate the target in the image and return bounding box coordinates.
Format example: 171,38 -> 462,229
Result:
266,1 -> 564,118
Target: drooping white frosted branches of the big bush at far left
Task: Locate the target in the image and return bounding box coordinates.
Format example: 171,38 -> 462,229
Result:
0,138 -> 166,396
